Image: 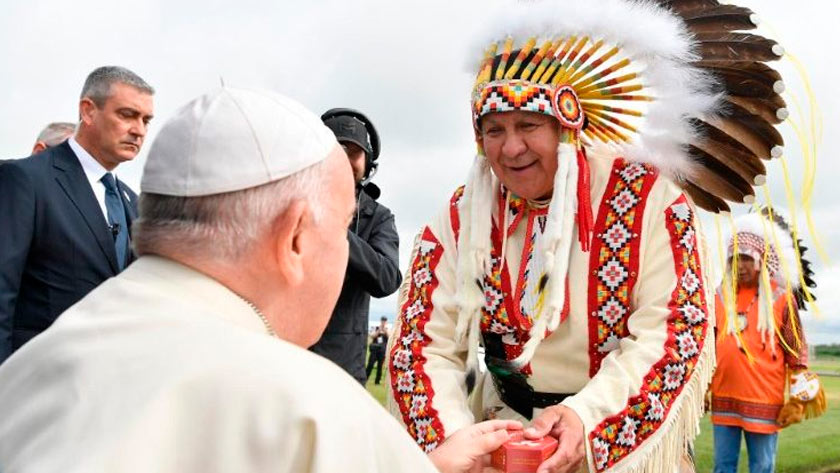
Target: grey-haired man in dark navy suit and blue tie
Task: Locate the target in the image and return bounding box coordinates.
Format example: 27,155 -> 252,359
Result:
0,66 -> 154,363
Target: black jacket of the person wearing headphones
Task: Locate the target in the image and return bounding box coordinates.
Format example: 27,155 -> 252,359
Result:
311,186 -> 402,384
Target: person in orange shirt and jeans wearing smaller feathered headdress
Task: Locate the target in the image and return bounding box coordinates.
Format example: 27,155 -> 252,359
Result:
711,209 -> 824,473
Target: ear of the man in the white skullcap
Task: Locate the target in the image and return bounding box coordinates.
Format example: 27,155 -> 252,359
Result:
274,200 -> 312,286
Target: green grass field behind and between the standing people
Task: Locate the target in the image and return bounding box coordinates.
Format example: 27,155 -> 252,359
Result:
367,358 -> 840,473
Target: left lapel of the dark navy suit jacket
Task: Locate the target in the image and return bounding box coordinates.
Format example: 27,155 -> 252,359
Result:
53,141 -> 118,274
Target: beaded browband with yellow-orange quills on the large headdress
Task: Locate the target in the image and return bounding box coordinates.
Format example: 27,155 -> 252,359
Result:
473,36 -> 653,143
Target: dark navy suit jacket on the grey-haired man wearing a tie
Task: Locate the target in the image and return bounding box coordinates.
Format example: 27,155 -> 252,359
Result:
0,142 -> 137,363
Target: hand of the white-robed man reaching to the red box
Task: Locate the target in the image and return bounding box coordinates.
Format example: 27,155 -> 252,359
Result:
429,420 -> 522,473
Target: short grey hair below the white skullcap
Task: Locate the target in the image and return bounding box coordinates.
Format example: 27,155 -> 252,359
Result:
132,161 -> 327,262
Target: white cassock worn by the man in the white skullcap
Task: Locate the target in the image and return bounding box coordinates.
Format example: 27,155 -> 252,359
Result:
0,256 -> 436,473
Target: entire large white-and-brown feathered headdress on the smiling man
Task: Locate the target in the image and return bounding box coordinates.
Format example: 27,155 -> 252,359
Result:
472,0 -> 788,212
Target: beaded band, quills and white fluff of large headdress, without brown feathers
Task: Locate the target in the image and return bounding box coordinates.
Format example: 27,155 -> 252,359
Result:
472,0 -> 718,176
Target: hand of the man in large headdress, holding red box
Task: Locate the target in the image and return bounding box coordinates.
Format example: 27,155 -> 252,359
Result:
524,404 -> 586,473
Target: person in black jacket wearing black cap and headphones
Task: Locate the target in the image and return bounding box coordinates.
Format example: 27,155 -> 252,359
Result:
312,108 -> 402,385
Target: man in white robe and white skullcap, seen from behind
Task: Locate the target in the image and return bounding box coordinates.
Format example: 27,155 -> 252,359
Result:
0,89 -> 519,473
